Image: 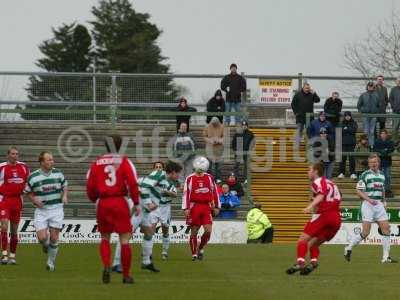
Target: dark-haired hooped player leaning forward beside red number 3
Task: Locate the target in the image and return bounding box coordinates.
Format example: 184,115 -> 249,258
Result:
140,161 -> 182,272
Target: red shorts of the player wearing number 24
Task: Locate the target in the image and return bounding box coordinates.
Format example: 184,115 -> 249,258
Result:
303,211 -> 342,241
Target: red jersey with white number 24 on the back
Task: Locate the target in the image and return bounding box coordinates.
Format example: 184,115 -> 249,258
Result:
311,176 -> 342,214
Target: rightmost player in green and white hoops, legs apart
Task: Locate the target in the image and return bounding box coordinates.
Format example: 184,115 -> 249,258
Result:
344,154 -> 397,263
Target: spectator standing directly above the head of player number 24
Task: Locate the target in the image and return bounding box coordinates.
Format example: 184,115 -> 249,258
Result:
312,127 -> 335,179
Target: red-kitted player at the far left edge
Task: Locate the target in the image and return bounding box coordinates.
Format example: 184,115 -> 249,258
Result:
0,147 -> 29,264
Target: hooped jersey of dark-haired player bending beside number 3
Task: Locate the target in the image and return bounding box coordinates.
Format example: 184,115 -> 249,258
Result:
139,170 -> 169,205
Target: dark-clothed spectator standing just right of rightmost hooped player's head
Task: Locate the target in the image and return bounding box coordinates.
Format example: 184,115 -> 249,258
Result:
374,129 -> 394,198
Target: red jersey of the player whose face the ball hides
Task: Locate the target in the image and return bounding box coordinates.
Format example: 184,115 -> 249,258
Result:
182,173 -> 221,209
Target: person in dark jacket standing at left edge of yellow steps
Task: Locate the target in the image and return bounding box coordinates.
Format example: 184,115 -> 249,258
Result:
231,121 -> 255,182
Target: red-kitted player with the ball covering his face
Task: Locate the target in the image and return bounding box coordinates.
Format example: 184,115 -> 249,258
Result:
182,157 -> 221,260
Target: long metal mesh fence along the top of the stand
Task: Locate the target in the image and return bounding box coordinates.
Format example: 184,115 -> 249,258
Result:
0,72 -> 394,122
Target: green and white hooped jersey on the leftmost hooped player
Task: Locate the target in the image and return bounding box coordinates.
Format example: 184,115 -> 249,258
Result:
25,168 -> 68,209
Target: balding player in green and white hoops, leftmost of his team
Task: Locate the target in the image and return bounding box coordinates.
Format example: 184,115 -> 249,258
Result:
25,151 -> 68,271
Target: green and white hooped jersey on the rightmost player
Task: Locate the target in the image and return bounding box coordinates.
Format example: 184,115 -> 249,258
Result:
357,170 -> 385,201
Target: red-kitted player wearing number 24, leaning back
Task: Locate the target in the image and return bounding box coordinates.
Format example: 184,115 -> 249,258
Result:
286,162 -> 342,275
